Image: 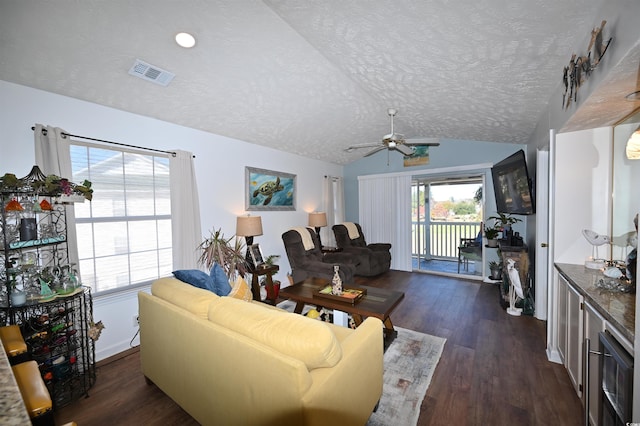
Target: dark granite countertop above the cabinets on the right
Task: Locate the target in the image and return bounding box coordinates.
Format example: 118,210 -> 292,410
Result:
555,263 -> 636,344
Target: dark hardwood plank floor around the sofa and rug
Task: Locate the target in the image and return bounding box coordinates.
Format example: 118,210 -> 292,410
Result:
56,271 -> 583,426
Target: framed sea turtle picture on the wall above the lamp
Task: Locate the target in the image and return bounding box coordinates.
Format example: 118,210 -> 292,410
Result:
245,167 -> 296,211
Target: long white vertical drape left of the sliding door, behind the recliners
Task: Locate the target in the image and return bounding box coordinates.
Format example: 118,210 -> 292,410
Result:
358,175 -> 412,271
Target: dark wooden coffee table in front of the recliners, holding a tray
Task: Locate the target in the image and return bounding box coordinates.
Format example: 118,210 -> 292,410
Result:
280,278 -> 404,348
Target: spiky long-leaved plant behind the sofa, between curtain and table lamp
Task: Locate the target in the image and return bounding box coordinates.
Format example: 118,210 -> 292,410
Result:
198,229 -> 248,281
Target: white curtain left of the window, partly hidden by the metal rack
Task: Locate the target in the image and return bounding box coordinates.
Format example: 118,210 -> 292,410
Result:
33,124 -> 80,270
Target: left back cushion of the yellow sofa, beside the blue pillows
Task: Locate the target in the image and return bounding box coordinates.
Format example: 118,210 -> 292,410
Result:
151,274 -> 220,319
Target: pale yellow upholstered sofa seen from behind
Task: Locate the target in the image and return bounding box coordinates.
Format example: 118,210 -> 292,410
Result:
138,278 -> 383,426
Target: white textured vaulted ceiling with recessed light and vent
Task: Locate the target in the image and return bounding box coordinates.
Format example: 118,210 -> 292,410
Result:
0,0 -> 637,164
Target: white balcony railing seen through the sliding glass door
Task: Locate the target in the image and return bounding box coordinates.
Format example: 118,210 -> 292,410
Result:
411,222 -> 482,260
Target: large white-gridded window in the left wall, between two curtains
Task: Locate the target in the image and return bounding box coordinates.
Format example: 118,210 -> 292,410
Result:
70,145 -> 173,294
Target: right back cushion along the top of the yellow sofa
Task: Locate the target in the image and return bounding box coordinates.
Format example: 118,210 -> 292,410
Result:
209,297 -> 342,370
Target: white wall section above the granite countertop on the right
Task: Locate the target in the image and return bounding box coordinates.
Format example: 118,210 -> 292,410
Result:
553,127 -> 613,265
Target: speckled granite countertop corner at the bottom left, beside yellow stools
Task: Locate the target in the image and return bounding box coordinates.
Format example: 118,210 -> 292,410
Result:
0,345 -> 31,426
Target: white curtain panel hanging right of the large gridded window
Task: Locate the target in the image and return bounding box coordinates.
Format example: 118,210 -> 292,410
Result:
169,150 -> 202,270
